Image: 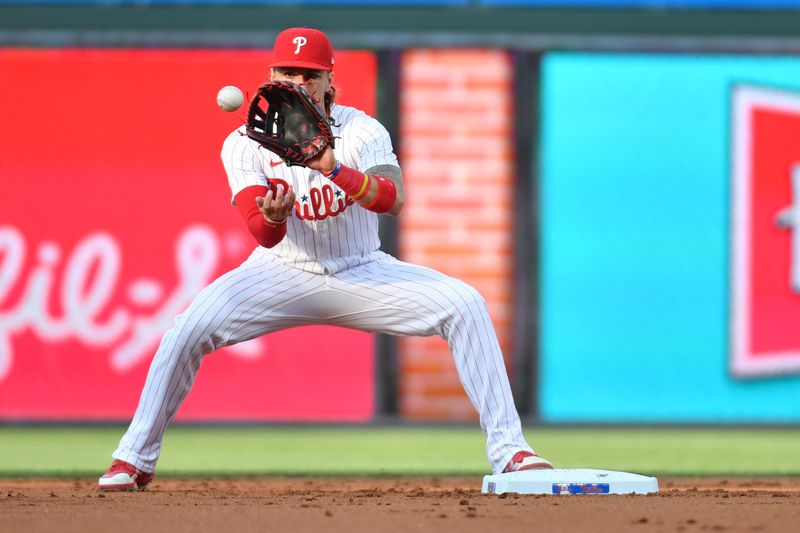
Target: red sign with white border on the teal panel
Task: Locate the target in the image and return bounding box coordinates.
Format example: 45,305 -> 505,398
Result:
731,86 -> 800,376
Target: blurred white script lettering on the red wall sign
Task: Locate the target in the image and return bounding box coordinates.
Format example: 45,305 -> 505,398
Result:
0,225 -> 258,382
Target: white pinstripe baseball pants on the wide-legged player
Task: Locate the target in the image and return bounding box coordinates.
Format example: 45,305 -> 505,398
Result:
113,252 -> 531,472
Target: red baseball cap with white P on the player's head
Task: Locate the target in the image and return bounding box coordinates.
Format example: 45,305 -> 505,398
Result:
269,28 -> 333,70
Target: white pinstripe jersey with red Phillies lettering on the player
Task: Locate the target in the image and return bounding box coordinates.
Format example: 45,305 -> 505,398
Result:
221,104 -> 397,274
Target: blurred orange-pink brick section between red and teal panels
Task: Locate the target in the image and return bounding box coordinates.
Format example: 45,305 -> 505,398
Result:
398,49 -> 514,420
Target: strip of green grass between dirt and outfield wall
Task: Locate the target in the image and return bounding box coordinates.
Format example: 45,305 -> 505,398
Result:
0,426 -> 800,477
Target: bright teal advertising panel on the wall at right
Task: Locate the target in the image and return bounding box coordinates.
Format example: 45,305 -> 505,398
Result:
539,53 -> 800,423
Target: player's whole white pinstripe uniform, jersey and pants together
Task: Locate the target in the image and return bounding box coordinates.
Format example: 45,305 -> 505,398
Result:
113,105 -> 531,472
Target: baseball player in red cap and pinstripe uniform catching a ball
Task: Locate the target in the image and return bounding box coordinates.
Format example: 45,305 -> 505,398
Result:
98,28 -> 553,491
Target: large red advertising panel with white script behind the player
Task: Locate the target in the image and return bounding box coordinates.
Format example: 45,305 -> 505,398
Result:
0,49 -> 376,421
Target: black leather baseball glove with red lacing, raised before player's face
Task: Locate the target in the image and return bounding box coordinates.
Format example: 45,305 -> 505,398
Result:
245,81 -> 333,167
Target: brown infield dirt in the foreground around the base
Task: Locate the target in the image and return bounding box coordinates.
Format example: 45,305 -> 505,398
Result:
0,477 -> 800,533
